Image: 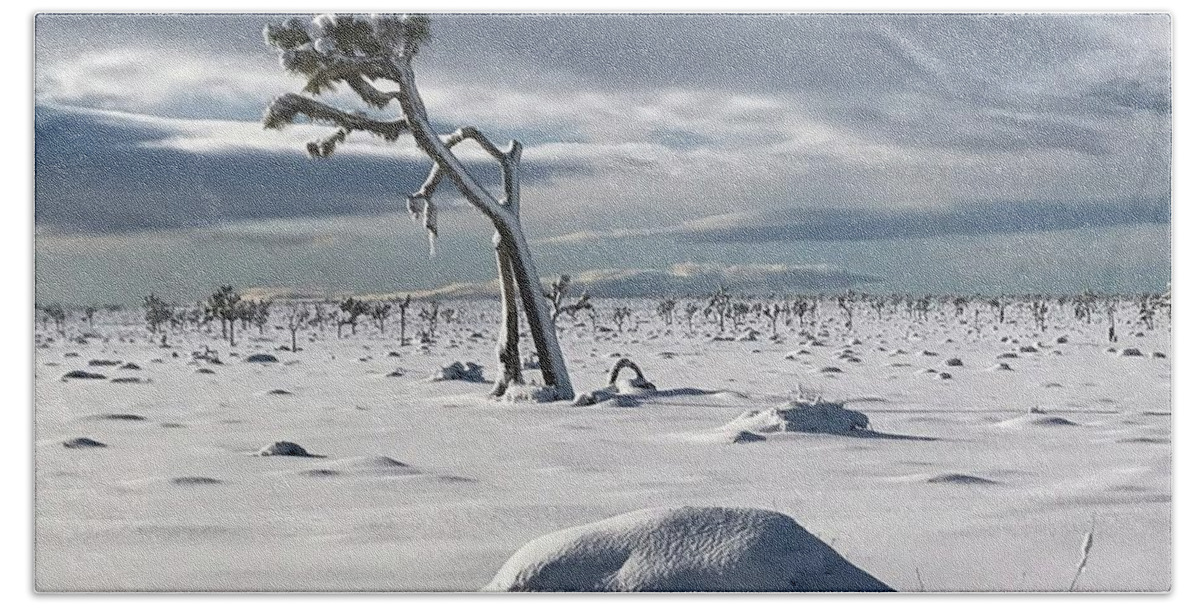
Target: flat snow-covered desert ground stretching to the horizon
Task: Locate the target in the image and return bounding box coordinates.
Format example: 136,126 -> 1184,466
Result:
35,300 -> 1171,591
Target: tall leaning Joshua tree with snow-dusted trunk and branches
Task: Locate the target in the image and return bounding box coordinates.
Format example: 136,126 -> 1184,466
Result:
263,16 -> 574,399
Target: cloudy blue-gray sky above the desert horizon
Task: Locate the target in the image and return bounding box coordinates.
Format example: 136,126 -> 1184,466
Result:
35,14 -> 1171,303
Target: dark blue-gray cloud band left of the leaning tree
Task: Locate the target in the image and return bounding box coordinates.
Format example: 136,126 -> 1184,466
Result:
34,107 -> 572,233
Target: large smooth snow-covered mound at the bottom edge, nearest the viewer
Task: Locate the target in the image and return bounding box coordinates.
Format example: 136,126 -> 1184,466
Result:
482,507 -> 892,591
